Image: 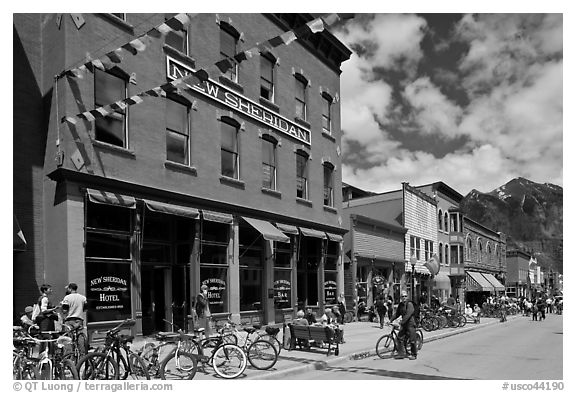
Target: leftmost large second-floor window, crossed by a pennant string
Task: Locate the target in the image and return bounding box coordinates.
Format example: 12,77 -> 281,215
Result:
94,69 -> 128,148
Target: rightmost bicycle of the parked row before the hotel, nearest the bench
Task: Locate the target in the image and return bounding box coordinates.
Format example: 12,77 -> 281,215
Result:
220,315 -> 280,370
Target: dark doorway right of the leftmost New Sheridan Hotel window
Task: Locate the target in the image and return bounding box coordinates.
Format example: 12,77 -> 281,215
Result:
142,265 -> 172,335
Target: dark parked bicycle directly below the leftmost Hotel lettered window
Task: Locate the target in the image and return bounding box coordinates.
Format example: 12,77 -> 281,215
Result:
77,319 -> 150,380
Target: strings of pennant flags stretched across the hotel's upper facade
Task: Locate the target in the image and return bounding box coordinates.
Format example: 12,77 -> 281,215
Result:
61,13 -> 354,124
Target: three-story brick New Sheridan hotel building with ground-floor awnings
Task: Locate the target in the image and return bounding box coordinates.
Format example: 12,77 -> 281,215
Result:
13,14 -> 351,334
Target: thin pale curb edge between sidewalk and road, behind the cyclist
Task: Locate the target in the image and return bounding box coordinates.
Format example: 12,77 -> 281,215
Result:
244,318 -> 516,380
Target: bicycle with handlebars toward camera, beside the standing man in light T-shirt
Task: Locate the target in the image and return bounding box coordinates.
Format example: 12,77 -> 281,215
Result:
28,327 -> 78,380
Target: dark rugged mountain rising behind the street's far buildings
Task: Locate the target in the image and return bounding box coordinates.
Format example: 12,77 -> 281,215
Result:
460,177 -> 563,273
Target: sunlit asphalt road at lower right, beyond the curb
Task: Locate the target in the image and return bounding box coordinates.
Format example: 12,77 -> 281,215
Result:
286,314 -> 563,380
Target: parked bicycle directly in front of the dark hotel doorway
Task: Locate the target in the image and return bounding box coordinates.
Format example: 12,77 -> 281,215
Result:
139,319 -> 198,379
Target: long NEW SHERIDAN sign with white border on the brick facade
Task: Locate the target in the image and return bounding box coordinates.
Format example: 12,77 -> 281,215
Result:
166,56 -> 310,145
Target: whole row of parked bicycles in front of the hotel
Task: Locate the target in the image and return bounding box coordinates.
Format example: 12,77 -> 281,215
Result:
13,318 -> 285,380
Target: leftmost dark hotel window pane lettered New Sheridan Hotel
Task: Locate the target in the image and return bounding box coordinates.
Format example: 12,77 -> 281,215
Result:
86,262 -> 132,322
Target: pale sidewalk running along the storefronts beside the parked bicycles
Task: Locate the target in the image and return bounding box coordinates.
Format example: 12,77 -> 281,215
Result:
134,315 -> 521,380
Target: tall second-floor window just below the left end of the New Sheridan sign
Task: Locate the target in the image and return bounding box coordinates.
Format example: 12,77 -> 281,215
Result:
166,99 -> 190,165
